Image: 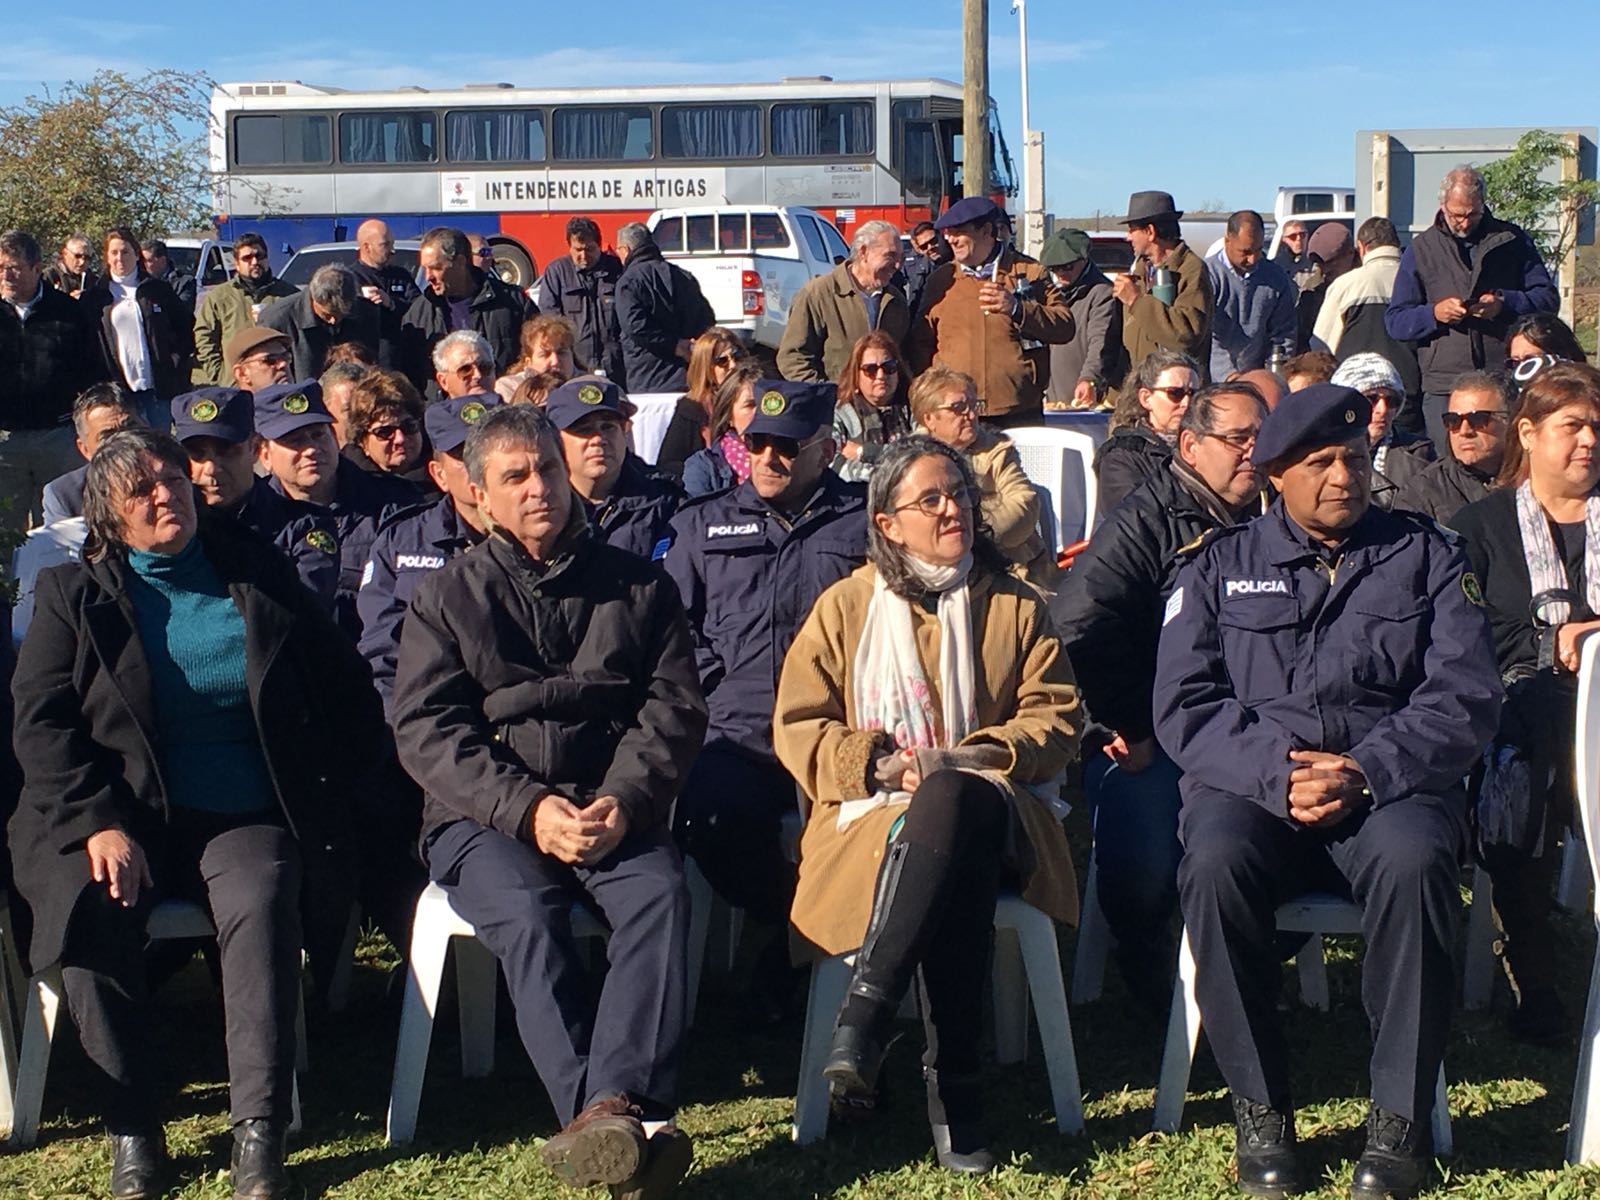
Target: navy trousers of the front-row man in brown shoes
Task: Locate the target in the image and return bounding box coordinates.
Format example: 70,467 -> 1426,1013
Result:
427,819 -> 690,1125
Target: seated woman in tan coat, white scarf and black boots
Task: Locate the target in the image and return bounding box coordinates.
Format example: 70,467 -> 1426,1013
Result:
773,437 -> 1083,1171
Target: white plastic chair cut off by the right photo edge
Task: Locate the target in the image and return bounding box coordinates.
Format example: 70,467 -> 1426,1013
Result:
1566,637 -> 1600,1163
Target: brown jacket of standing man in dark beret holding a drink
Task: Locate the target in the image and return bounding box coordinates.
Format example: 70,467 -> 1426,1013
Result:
907,245 -> 1074,418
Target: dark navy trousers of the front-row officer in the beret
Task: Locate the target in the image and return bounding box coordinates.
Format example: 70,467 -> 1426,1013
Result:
1178,797 -> 1466,1122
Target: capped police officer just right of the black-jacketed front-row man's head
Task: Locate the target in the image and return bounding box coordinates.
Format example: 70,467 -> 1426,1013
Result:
544,374 -> 683,558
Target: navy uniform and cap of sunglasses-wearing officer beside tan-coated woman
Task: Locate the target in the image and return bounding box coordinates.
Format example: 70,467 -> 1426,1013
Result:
666,379 -> 867,922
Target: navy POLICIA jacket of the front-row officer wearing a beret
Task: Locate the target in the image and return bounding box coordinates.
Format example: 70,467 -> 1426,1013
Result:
1154,499 -> 1502,821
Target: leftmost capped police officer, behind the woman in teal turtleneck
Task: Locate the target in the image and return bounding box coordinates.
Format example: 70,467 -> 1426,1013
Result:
173,387 -> 339,611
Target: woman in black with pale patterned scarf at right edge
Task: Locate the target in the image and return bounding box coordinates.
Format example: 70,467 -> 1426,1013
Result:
1454,363 -> 1600,1042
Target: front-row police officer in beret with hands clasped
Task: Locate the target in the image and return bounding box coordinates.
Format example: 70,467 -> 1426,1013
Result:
1155,384 -> 1501,1200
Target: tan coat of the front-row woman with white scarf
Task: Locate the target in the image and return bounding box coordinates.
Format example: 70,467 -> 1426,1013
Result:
773,563 -> 1083,954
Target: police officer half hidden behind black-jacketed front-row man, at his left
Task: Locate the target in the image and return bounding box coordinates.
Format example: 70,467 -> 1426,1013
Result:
355,392 -> 501,715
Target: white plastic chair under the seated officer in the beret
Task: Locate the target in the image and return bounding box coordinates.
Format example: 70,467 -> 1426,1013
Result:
1154,893 -> 1454,1158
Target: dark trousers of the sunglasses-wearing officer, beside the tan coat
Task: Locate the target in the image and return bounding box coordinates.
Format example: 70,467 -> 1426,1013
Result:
677,747 -> 798,925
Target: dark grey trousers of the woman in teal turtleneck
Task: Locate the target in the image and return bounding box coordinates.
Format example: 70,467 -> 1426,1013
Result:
61,811 -> 301,1131
